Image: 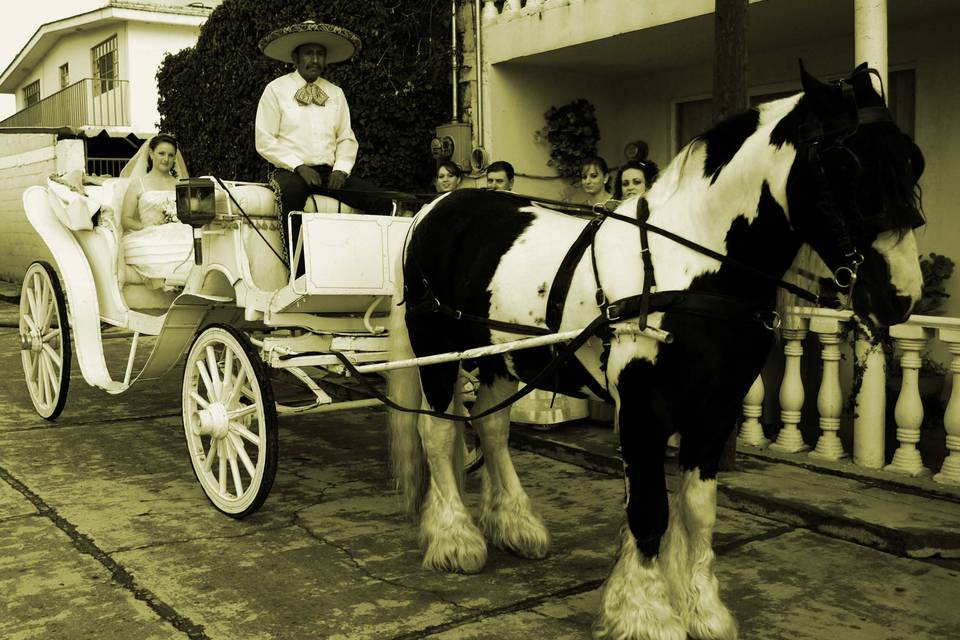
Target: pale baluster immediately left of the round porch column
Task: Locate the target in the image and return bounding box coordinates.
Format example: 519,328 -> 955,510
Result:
810,318 -> 845,460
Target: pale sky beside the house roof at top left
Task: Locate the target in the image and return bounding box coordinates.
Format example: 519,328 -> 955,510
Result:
0,0 -> 118,119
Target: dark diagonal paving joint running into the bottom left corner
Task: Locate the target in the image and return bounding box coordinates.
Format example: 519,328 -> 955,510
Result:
0,466 -> 211,640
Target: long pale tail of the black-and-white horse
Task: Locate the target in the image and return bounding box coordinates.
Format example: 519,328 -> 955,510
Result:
387,244 -> 428,515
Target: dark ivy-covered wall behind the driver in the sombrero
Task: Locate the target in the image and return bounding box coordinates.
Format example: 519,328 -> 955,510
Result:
157,0 -> 452,191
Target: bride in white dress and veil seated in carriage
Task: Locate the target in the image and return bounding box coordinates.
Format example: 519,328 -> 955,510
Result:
120,133 -> 193,289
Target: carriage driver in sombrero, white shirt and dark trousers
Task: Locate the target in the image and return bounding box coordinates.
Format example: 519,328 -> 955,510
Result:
256,20 -> 391,270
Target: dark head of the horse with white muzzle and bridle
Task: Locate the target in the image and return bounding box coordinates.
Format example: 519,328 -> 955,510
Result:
787,64 -> 924,325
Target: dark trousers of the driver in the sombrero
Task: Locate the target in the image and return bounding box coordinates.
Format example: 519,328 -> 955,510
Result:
273,165 -> 393,276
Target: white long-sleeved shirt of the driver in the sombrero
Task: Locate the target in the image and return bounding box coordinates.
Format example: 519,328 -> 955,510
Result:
256,71 -> 358,174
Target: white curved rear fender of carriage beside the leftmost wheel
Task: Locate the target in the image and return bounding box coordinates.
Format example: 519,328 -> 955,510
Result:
23,186 -> 119,391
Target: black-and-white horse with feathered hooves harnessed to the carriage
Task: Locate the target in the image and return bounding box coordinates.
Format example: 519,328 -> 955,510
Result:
388,63 -> 923,640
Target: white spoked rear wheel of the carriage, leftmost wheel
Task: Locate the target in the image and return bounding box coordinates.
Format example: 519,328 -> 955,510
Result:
20,262 -> 70,420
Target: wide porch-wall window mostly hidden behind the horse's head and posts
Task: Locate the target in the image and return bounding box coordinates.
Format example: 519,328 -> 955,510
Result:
676,69 -> 916,151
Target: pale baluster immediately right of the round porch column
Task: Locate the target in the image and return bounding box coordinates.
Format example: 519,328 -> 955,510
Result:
884,324 -> 931,476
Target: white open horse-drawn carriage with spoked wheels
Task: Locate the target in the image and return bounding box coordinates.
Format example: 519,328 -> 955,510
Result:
20,172 -> 492,517
